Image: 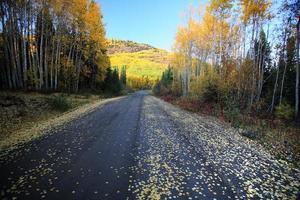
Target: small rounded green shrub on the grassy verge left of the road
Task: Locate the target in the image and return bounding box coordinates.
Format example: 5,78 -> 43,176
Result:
47,95 -> 72,112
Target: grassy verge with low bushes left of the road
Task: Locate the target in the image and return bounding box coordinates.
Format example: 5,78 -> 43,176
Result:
0,91 -> 106,140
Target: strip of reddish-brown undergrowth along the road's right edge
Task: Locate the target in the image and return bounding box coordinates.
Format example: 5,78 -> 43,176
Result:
159,95 -> 300,168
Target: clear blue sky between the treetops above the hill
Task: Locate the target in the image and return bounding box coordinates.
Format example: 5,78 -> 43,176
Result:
97,0 -> 206,50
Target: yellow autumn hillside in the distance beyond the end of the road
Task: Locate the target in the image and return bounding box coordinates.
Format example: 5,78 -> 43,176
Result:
108,40 -> 169,80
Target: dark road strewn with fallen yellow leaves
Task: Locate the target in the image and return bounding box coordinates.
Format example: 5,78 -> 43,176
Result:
0,91 -> 300,200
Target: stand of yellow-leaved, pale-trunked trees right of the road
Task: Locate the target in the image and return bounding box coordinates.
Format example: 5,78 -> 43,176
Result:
154,0 -> 300,119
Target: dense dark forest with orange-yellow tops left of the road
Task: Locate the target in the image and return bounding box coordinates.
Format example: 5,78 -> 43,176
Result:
0,0 -> 120,92
